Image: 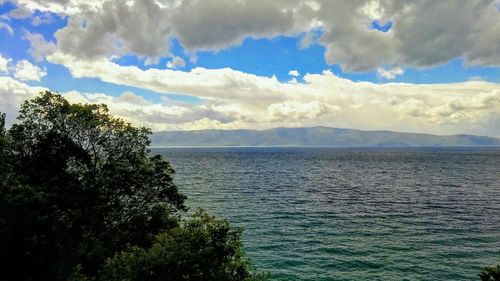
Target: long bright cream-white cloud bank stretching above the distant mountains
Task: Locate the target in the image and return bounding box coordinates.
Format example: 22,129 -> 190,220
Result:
44,53 -> 500,136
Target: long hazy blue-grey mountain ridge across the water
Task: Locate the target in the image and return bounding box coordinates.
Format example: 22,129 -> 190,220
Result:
151,127 -> 500,146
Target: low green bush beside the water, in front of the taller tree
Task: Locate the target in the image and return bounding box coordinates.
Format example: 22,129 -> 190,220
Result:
101,210 -> 265,281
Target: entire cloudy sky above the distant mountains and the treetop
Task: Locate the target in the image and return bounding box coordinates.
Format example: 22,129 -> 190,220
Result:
0,0 -> 500,137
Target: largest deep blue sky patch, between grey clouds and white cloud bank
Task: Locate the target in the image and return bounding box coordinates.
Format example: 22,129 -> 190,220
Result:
115,35 -> 350,82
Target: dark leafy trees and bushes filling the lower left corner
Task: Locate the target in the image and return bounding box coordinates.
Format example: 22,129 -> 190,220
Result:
0,92 -> 264,281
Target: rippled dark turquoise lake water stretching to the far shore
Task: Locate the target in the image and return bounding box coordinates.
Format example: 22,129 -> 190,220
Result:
153,148 -> 500,280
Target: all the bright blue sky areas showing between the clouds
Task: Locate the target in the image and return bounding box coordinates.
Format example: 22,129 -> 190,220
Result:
0,1 -> 500,93
